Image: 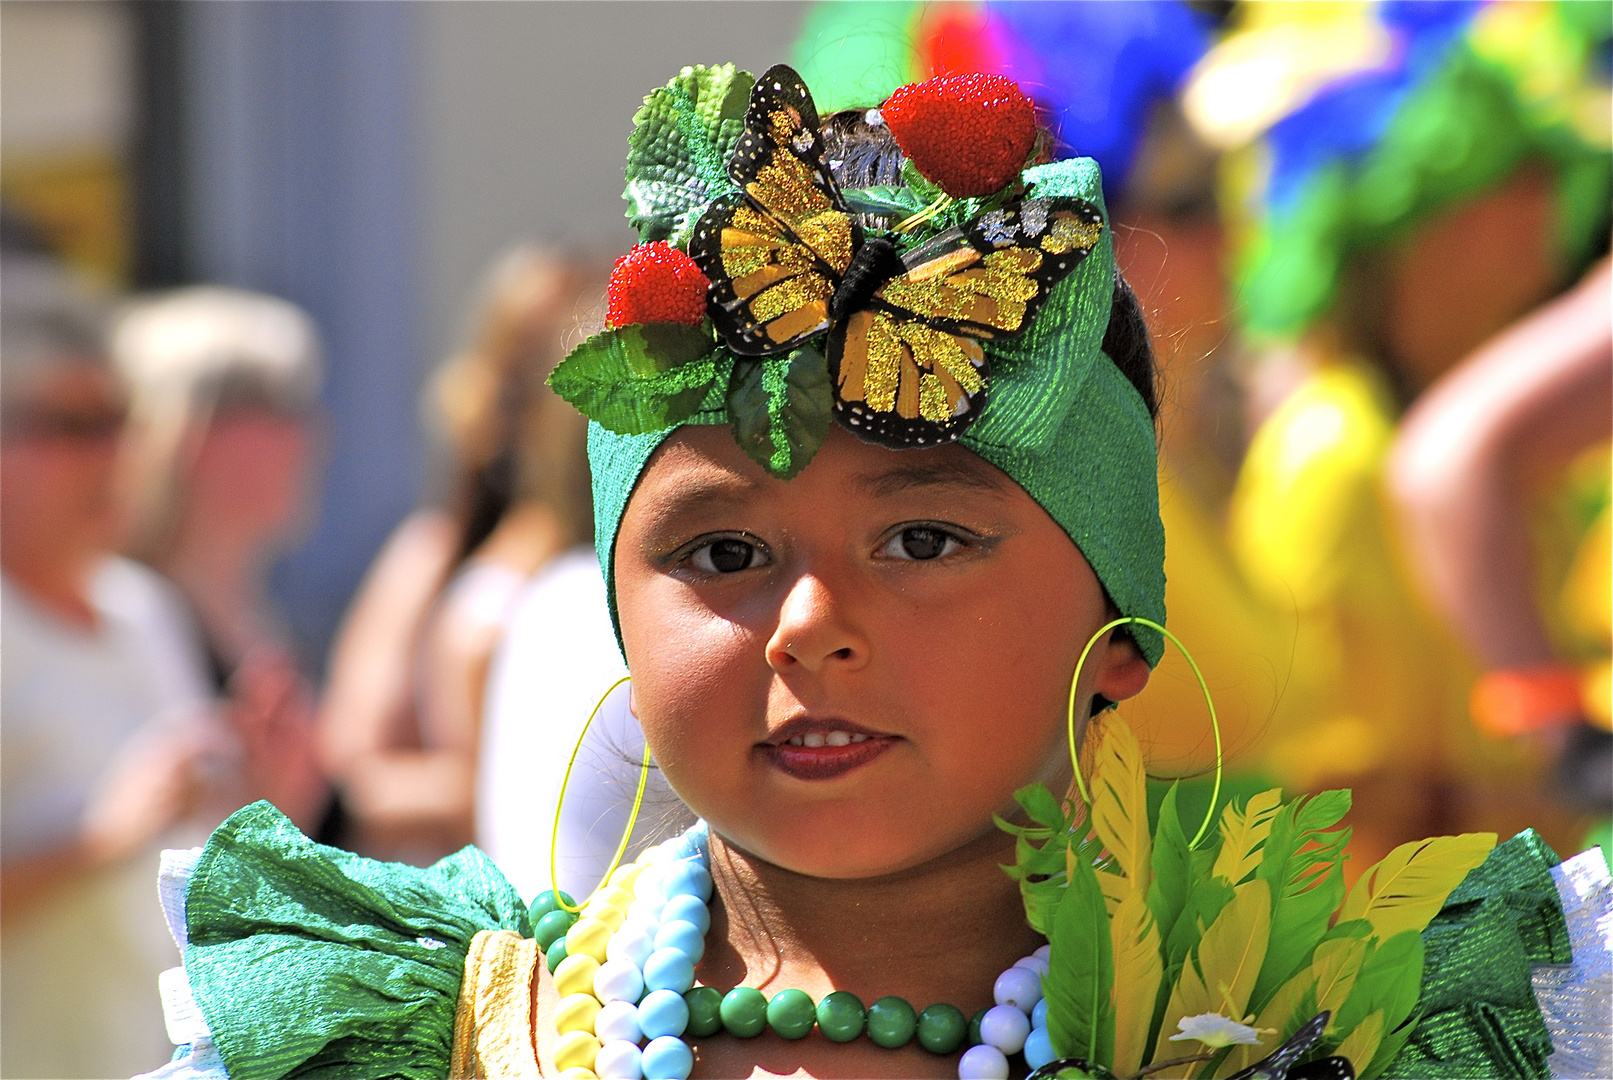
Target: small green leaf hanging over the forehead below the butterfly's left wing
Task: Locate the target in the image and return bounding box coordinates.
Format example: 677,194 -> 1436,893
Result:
727,345 -> 834,480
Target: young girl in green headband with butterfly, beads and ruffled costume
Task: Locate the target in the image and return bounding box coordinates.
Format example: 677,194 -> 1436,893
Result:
145,57 -> 1606,1080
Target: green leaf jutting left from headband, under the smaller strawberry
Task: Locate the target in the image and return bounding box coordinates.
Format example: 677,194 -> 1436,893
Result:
548,322 -> 719,435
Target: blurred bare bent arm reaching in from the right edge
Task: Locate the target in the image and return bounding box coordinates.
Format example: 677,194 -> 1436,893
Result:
1389,261 -> 1613,669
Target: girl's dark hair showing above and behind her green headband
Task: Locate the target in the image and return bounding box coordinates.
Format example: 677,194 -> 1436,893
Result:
823,110 -> 1160,417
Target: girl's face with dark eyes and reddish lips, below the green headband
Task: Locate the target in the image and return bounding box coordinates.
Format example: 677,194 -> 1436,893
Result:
616,426 -> 1148,879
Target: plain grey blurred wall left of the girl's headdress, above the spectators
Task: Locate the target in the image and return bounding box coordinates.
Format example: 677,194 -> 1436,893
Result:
416,2 -> 807,364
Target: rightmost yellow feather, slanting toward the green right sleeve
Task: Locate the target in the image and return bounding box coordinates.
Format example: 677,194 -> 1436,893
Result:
1339,832 -> 1495,941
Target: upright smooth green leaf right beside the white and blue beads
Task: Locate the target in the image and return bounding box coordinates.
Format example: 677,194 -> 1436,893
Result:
1042,859 -> 1115,1061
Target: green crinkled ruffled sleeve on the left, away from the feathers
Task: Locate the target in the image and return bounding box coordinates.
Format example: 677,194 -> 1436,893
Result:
185,803 -> 531,1080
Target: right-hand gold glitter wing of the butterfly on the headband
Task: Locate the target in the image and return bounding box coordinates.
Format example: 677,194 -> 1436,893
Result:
829,198 -> 1103,448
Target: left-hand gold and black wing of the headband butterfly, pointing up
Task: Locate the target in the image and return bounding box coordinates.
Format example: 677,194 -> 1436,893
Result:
689,64 -> 863,356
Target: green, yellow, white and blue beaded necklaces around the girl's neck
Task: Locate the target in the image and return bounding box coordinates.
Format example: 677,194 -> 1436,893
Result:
531,822 -> 1057,1080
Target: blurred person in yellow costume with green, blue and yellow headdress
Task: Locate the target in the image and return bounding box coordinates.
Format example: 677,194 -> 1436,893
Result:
1173,3 -> 1610,861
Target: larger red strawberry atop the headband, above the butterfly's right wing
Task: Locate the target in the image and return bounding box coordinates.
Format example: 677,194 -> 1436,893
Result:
879,73 -> 1036,198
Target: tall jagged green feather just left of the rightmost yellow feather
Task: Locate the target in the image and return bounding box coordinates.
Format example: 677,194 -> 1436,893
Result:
1250,791 -> 1350,1012
